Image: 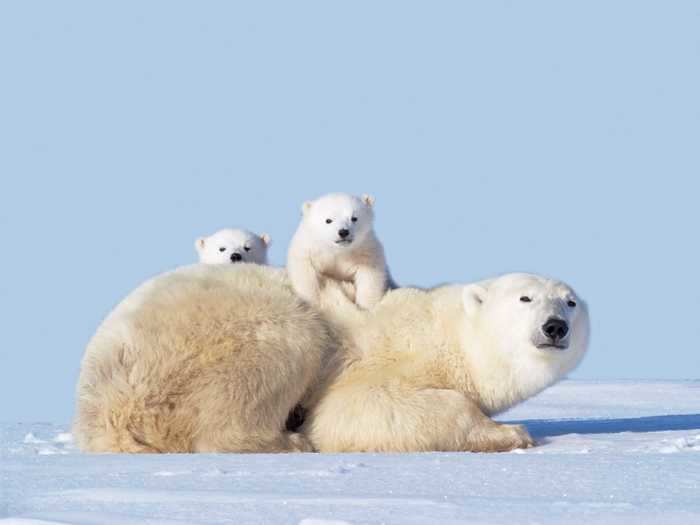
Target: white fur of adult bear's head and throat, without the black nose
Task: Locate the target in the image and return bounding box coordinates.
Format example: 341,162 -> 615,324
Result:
462,273 -> 590,414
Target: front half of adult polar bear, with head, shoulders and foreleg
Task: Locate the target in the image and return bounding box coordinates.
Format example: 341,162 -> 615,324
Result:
302,274 -> 589,452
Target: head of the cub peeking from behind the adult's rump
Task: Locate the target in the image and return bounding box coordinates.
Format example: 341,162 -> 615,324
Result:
194,229 -> 270,264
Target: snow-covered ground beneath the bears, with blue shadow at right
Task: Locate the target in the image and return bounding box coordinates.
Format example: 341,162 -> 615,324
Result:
0,381 -> 700,525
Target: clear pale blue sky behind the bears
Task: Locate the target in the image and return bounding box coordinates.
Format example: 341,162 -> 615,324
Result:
0,0 -> 700,421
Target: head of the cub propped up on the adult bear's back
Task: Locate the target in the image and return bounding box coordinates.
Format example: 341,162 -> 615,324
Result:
302,193 -> 374,249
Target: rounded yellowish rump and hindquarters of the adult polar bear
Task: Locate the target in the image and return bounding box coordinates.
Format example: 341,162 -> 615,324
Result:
74,264 -> 333,452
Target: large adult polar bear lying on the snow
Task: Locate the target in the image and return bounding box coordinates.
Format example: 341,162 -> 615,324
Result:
75,264 -> 588,452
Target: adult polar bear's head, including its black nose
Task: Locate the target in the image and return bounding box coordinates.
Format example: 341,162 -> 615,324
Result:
462,273 -> 590,408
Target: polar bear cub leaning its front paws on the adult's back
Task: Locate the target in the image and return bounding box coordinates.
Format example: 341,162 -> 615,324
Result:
287,193 -> 391,309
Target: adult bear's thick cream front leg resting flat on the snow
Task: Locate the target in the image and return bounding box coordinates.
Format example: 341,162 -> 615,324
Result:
302,381 -> 534,452
